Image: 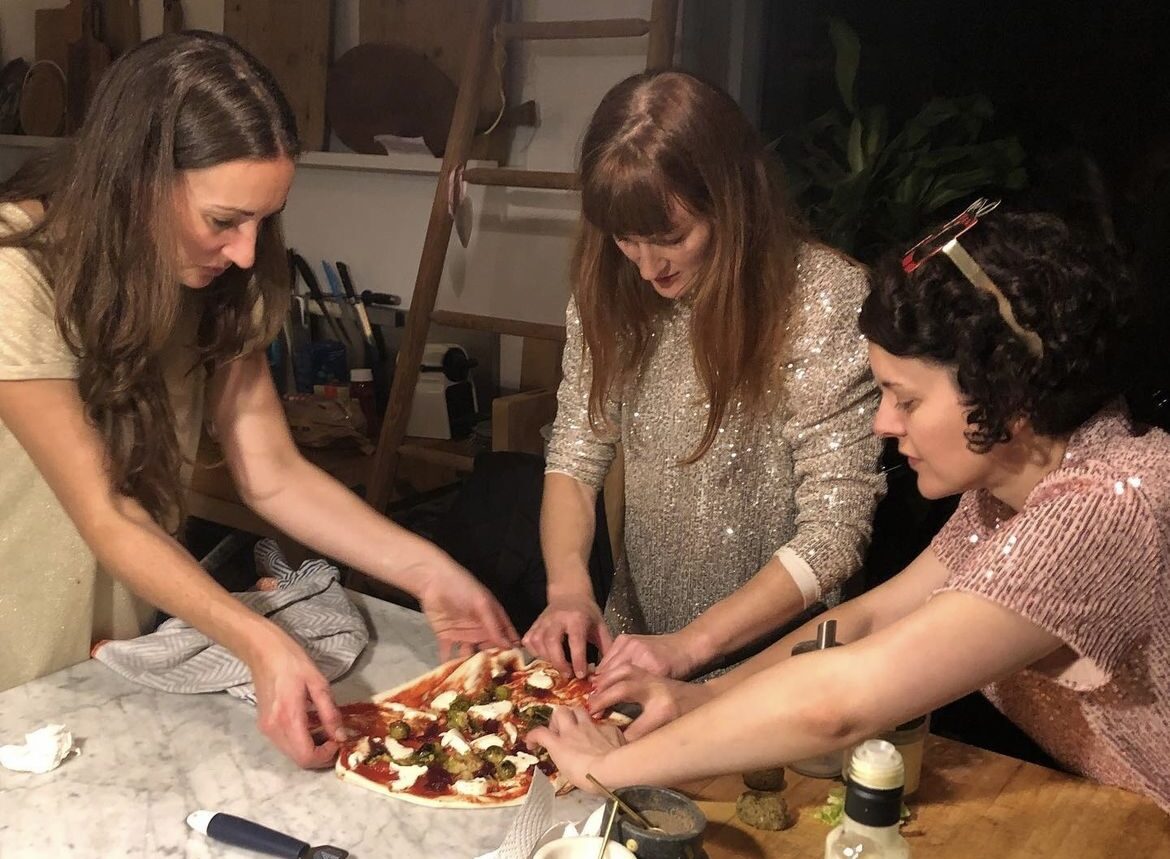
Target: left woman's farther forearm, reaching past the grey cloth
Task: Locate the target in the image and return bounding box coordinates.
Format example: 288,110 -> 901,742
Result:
237,455 -> 442,595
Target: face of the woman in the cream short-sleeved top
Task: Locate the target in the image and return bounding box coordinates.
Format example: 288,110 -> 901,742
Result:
174,158 -> 294,289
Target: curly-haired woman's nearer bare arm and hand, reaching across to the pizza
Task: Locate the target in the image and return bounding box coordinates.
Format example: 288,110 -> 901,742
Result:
530,592 -> 1061,785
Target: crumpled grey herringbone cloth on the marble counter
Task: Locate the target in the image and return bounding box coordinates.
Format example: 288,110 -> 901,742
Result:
94,540 -> 370,703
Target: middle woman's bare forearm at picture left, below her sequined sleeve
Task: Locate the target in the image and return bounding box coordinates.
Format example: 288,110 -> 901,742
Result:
541,473 -> 597,598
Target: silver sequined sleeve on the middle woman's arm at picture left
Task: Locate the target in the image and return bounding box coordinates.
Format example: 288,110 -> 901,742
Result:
545,300 -> 620,490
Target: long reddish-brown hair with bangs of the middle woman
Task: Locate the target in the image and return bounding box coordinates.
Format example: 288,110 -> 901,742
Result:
572,71 -> 803,463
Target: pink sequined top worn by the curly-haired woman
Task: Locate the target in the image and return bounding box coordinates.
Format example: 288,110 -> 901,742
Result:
931,408 -> 1170,812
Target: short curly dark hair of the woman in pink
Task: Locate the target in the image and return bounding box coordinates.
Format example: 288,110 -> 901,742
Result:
860,208 -> 1133,453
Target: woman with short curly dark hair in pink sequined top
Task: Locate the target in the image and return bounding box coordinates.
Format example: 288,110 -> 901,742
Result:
530,201 -> 1170,811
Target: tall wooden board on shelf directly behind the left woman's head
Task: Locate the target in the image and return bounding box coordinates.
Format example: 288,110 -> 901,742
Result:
223,0 -> 331,150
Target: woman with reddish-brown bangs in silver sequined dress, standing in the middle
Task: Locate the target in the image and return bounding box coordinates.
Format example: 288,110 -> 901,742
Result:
524,71 -> 882,678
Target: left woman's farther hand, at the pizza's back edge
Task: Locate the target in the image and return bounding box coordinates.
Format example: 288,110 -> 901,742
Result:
415,552 -> 519,659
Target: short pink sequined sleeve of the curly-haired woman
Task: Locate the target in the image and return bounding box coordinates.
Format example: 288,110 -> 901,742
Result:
931,475 -> 1159,688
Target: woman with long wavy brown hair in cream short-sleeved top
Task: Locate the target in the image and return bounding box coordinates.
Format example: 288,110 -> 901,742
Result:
0,33 -> 515,765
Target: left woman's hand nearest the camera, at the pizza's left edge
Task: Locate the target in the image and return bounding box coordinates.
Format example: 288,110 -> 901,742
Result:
248,621 -> 345,768
